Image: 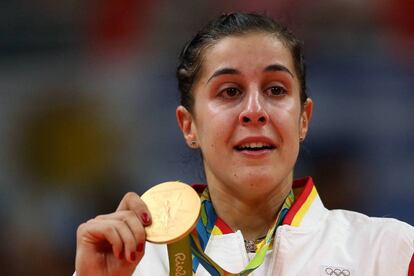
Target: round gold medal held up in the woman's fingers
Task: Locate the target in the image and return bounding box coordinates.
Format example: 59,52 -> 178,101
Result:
141,181 -> 201,244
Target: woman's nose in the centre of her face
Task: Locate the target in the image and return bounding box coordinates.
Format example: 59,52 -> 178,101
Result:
239,92 -> 269,126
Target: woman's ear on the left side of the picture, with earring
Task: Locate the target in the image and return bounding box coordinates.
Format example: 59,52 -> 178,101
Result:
175,105 -> 198,148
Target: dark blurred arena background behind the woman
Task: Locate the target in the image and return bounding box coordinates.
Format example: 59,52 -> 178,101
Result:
0,0 -> 414,275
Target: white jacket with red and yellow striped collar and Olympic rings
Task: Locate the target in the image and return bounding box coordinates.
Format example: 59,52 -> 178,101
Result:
133,178 -> 414,276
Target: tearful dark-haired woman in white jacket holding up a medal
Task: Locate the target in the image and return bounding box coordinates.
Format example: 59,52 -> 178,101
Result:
76,13 -> 414,275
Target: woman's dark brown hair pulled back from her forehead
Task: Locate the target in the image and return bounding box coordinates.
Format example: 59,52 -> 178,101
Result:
176,12 -> 308,112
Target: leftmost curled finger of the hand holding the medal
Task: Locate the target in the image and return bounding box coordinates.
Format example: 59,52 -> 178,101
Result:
77,219 -> 123,259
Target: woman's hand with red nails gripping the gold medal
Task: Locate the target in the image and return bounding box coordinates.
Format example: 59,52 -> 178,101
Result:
76,192 -> 151,276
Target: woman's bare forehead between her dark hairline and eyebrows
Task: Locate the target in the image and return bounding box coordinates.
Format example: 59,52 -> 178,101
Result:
200,33 -> 295,79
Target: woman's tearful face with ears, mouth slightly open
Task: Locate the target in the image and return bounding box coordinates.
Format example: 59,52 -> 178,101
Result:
177,33 -> 312,194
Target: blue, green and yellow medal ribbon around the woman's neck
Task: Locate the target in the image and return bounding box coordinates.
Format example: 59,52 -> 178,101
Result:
190,187 -> 295,276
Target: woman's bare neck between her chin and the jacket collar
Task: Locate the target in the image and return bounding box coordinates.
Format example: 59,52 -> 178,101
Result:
208,175 -> 292,240
